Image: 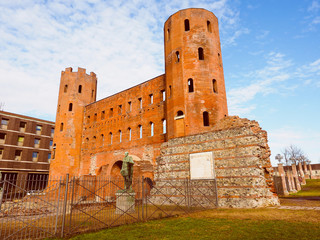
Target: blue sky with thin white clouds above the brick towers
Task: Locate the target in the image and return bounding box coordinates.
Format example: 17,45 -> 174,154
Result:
0,0 -> 320,164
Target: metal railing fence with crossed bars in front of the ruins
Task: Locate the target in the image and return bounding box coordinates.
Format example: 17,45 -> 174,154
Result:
0,175 -> 218,239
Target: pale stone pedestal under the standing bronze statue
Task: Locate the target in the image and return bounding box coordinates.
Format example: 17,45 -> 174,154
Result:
115,192 -> 136,214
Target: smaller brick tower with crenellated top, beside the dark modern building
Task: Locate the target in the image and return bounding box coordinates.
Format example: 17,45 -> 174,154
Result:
50,68 -> 97,176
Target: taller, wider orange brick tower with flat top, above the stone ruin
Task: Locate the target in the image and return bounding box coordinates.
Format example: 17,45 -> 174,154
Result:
164,8 -> 228,139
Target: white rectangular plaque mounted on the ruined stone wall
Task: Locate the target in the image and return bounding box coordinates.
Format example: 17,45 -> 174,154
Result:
190,152 -> 216,179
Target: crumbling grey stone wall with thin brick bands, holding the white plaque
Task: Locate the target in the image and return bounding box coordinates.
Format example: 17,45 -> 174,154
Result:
155,117 -> 279,208
